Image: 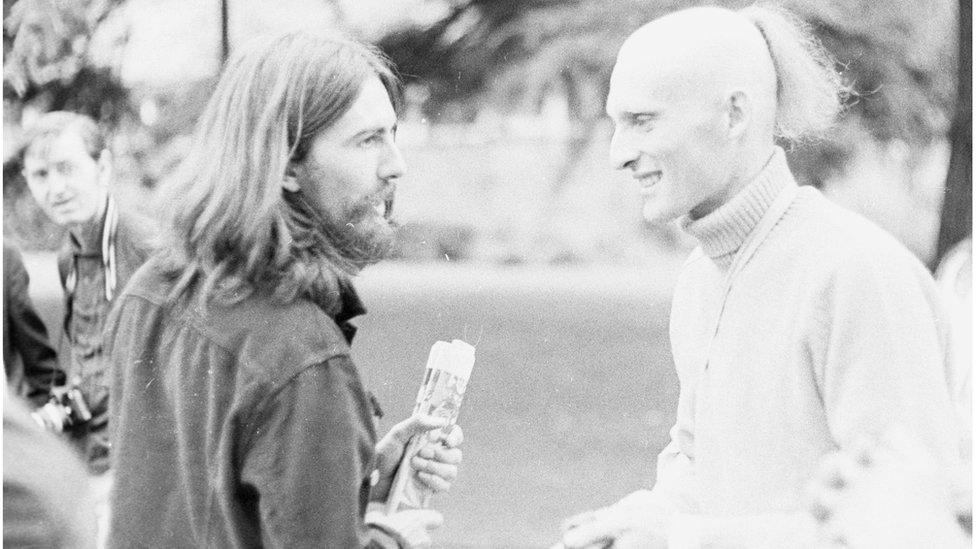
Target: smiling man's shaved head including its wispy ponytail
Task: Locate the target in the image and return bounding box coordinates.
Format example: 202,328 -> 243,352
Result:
607,7 -> 839,222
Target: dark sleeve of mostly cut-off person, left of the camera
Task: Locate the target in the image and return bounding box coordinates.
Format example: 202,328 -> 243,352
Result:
4,246 -> 65,406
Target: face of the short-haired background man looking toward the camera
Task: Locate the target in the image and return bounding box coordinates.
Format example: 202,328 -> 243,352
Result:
24,130 -> 109,225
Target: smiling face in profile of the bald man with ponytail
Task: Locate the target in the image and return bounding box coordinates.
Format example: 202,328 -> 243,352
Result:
607,54 -> 731,223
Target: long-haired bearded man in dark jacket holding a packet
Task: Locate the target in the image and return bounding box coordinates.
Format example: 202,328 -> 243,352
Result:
106,33 -> 461,547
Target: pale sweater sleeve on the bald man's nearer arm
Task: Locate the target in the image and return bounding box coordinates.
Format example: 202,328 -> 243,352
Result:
809,250 -> 956,465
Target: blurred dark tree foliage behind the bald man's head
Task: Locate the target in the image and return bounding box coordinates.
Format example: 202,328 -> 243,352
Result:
379,0 -> 956,185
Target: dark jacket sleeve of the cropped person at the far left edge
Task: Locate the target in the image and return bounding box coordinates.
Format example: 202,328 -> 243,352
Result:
3,241 -> 65,406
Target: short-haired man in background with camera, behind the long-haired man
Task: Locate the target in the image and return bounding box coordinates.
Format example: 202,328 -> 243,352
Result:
23,112 -> 148,474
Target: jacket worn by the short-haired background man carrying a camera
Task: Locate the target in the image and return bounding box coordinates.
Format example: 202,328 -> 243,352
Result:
58,201 -> 154,474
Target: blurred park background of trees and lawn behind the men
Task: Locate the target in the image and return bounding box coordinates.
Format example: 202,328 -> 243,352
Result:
3,0 -> 972,547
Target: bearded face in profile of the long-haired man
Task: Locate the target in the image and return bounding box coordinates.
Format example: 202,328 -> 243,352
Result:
296,74 -> 405,258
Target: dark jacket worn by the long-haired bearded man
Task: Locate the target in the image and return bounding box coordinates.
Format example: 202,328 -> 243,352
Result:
105,260 -> 392,548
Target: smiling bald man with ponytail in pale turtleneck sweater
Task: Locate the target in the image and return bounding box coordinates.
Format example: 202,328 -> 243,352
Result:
562,7 -> 956,548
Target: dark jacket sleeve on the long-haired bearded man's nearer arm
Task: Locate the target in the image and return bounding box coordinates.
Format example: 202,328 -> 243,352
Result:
240,356 -> 395,547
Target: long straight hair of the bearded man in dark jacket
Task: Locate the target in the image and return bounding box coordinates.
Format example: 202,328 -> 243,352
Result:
160,32 -> 400,313
